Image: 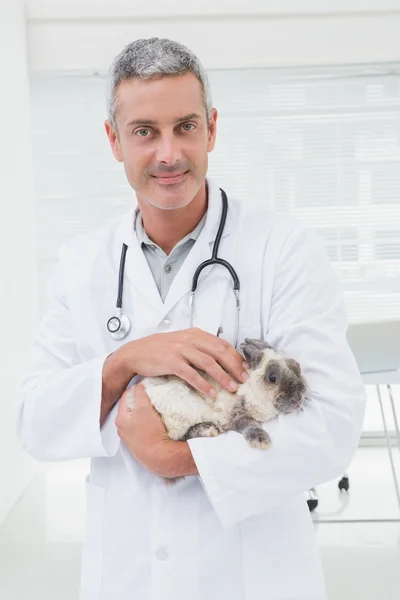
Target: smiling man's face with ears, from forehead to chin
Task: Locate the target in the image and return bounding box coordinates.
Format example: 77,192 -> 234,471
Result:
105,73 -> 217,210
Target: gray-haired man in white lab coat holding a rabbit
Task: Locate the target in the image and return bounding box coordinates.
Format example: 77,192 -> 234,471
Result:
19,38 -> 365,600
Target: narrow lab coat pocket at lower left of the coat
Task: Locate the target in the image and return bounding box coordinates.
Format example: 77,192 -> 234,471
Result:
80,475 -> 106,600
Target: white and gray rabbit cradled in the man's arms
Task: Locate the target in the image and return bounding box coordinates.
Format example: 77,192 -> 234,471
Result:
128,338 -> 306,449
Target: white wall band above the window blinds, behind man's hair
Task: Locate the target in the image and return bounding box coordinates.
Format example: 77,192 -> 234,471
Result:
25,0 -> 400,71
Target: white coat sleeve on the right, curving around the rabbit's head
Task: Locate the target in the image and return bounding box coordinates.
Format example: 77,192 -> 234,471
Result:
184,226 -> 366,526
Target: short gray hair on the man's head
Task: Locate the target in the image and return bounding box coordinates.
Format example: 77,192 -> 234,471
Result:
107,38 -> 212,132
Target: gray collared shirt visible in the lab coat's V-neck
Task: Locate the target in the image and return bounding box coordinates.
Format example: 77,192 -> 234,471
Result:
135,211 -> 207,302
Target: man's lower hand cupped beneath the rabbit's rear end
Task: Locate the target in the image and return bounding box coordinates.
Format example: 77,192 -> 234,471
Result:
115,385 -> 197,478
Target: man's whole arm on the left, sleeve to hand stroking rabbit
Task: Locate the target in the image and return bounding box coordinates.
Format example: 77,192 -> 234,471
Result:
17,240 -> 247,461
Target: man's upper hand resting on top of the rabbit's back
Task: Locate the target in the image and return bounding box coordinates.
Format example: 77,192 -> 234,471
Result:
118,328 -> 248,397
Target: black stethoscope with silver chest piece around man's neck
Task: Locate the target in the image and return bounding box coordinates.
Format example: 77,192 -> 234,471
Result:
107,188 -> 240,348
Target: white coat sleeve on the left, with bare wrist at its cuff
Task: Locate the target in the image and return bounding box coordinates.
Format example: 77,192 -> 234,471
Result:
16,246 -> 126,461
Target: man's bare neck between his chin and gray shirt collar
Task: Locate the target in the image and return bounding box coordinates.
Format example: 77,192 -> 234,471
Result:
138,181 -> 208,255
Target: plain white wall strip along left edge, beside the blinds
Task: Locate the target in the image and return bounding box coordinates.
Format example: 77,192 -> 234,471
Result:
0,0 -> 37,523
